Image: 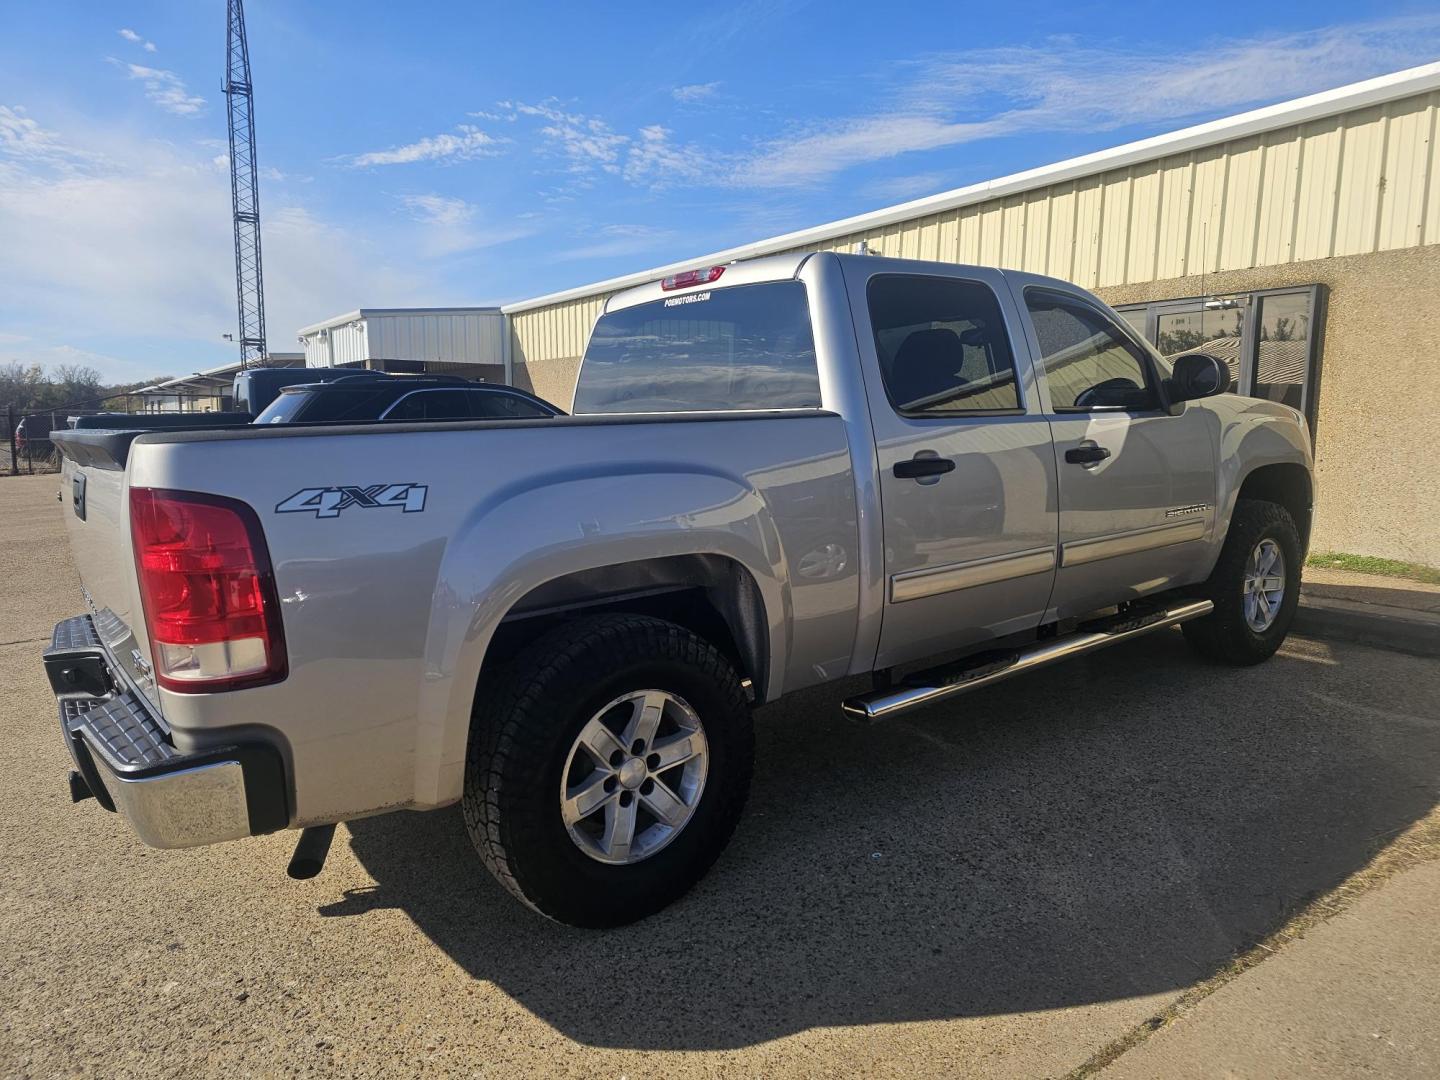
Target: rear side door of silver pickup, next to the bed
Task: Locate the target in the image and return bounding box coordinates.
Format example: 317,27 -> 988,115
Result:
844,258 -> 1057,667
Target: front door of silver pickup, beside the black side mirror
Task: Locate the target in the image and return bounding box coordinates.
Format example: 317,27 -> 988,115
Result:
1014,275 -> 1218,619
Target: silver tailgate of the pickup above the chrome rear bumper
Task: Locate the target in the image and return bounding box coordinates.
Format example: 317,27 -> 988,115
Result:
55,431 -> 160,708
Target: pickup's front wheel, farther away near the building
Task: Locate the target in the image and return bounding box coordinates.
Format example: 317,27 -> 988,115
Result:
1182,498 -> 1300,667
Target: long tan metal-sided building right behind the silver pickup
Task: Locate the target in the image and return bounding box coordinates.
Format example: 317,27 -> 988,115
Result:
503,63 -> 1440,564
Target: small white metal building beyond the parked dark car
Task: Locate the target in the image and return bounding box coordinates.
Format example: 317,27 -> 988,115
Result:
300,308 -> 508,383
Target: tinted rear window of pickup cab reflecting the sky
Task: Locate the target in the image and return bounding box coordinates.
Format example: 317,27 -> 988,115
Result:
575,281 -> 821,415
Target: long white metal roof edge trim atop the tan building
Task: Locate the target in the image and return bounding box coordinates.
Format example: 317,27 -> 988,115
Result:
501,62 -> 1440,315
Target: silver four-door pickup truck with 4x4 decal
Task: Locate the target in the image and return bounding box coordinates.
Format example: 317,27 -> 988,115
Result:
45,253 -> 1313,926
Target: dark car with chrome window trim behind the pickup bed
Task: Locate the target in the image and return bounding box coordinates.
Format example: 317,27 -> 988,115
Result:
255,373 -> 563,423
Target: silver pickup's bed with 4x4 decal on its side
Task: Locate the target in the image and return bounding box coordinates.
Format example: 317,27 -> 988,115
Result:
59,410 -> 860,824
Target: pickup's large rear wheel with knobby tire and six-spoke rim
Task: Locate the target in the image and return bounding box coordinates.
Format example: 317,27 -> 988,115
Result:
462,615 -> 755,927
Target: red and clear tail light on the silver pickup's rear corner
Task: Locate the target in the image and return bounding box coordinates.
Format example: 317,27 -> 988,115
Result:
130,488 -> 287,693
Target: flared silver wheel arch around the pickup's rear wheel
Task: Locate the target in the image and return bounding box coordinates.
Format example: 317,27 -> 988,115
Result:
412,472 -> 792,808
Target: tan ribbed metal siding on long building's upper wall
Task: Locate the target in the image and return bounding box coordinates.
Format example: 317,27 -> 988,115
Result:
513,91 -> 1440,363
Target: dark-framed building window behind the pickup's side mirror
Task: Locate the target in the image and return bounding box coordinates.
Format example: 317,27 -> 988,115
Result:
1116,285 -> 1325,426
